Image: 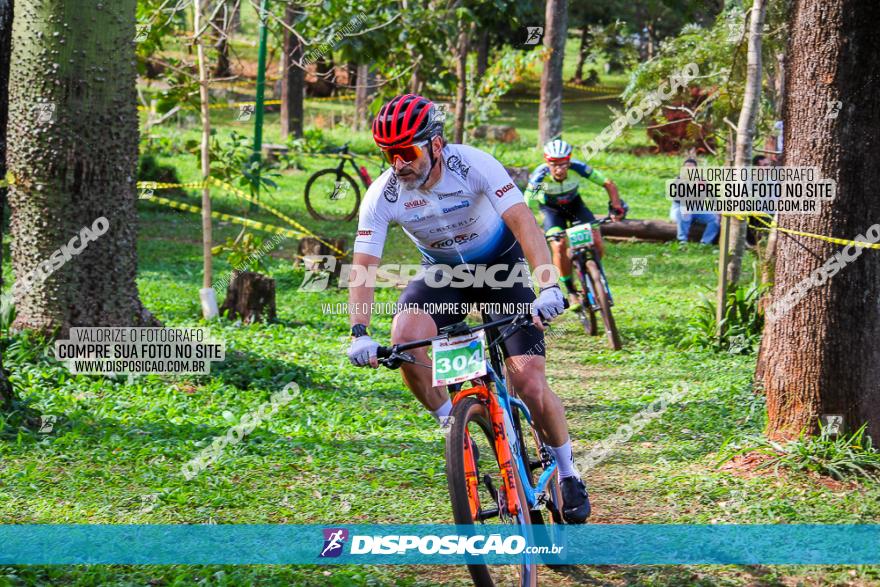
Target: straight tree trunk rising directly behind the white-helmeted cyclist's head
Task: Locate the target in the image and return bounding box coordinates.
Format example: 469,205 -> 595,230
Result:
538,0 -> 568,147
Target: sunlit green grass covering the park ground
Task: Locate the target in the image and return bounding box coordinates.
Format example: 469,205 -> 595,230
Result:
0,41 -> 880,586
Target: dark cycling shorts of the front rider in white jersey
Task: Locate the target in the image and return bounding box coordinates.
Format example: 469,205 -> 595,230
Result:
397,243 -> 544,358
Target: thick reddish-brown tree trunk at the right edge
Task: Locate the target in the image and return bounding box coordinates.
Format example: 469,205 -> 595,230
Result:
757,0 -> 880,442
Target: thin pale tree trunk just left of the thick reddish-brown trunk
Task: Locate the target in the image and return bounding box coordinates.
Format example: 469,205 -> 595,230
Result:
727,0 -> 767,285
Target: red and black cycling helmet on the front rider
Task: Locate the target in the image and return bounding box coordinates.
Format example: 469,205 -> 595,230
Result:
373,94 -> 443,149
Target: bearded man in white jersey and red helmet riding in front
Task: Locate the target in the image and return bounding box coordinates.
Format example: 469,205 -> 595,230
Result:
348,94 -> 590,523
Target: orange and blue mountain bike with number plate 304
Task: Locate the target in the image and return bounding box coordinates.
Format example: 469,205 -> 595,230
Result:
377,314 -> 563,587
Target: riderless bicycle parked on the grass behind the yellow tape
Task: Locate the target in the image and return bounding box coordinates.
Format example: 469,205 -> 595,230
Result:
305,143 -> 373,222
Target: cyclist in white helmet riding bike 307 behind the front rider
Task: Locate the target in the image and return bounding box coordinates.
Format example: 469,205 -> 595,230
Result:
525,139 -> 627,306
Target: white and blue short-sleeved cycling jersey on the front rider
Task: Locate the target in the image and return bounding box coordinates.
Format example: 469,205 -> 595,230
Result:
354,145 -> 524,264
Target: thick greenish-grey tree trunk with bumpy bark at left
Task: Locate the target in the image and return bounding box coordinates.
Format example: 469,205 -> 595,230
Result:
8,0 -> 156,334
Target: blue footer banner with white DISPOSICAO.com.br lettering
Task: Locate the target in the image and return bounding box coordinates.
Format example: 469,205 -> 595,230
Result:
0,524 -> 880,565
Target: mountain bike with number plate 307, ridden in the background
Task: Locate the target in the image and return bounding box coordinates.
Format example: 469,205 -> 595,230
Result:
547,216 -> 623,351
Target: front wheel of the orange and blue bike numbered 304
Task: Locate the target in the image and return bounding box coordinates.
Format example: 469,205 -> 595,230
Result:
446,397 -> 537,587
